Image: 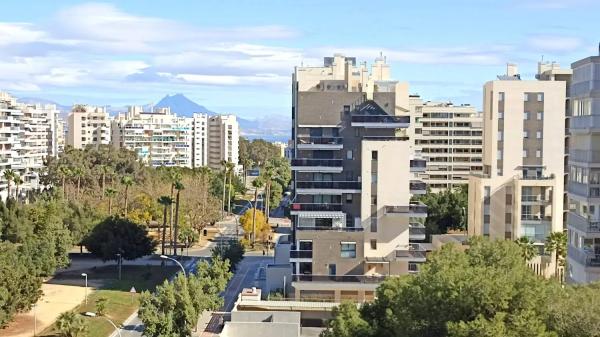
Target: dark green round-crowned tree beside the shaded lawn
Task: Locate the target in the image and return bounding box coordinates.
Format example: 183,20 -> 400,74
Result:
83,217 -> 157,261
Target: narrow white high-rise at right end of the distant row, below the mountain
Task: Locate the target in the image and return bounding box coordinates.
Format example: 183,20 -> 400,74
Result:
208,115 -> 240,169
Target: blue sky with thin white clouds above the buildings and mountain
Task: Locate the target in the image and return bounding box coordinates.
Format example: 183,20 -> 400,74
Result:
0,0 -> 600,118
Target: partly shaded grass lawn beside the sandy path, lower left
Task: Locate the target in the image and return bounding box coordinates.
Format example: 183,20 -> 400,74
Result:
39,265 -> 179,337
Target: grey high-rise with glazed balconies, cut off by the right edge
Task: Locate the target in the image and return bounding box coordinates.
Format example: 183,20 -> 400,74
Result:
566,56 -> 600,283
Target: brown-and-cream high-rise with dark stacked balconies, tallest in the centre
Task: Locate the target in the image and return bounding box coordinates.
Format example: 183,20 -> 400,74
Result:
267,55 -> 427,301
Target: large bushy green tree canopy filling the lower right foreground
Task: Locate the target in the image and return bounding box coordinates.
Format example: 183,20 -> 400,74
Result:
322,238 -> 600,337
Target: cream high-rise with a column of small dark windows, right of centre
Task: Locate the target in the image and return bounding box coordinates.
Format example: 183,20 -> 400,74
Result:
468,64 -> 568,276
